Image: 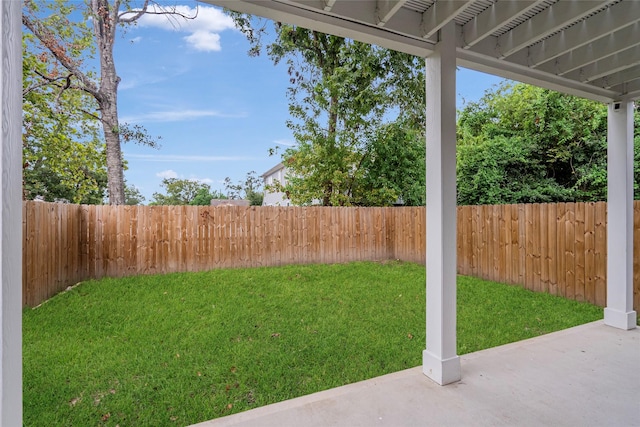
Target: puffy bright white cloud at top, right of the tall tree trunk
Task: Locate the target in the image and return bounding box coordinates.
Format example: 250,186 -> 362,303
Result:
130,5 -> 235,52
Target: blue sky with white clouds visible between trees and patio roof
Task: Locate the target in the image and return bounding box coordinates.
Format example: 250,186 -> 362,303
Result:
114,4 -> 500,203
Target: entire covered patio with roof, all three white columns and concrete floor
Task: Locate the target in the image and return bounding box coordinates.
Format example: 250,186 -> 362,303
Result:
0,0 -> 640,426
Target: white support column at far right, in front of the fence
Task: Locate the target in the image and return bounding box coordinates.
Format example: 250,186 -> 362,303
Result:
604,101 -> 636,330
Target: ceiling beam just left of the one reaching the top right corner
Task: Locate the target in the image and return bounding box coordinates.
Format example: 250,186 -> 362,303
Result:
498,0 -> 612,58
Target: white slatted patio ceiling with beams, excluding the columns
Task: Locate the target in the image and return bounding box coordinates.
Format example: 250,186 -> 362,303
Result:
205,0 -> 640,102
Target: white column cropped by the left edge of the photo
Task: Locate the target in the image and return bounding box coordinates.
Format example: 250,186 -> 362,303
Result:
0,0 -> 22,427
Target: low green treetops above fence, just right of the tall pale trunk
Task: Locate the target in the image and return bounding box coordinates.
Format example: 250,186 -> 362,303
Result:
150,178 -> 226,206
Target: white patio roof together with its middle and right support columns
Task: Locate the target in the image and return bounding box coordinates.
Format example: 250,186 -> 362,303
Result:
205,0 -> 640,384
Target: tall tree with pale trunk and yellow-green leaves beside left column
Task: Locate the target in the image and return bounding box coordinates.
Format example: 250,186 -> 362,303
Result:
22,0 -> 165,204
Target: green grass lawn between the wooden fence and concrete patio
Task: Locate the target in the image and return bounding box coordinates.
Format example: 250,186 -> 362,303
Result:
23,262 -> 602,427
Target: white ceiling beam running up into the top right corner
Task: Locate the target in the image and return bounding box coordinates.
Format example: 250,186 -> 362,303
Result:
529,1 -> 640,67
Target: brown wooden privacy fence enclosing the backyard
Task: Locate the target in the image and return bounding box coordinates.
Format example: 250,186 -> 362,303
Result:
23,202 -> 640,310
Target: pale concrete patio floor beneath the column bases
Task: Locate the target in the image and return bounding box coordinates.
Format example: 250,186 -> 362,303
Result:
197,321 -> 640,427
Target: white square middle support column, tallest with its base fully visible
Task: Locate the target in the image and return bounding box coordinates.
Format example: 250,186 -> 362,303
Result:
422,22 -> 460,385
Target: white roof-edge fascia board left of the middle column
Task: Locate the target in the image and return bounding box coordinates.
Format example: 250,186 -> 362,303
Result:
204,0 -> 433,58
